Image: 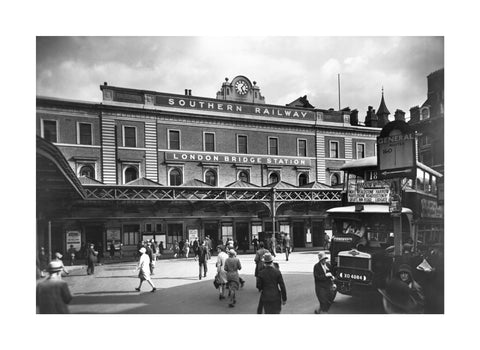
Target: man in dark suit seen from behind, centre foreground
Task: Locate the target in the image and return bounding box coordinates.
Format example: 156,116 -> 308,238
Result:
257,253 -> 287,314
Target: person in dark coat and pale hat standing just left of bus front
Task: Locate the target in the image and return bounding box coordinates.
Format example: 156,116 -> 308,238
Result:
313,251 -> 336,314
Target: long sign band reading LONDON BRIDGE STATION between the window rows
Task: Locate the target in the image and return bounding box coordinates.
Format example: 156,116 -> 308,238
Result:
165,151 -> 311,167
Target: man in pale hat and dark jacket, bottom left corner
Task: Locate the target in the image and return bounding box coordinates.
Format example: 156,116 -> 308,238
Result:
37,261 -> 72,314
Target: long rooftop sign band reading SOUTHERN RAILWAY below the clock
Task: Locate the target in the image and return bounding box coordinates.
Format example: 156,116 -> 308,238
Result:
155,95 -> 315,120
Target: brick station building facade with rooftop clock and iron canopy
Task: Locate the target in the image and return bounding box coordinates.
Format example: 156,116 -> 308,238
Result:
36,76 -> 381,252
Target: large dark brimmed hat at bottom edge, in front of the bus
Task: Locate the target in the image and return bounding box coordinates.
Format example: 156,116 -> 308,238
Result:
378,279 -> 418,314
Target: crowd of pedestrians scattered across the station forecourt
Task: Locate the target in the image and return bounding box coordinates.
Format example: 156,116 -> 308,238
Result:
37,235 -> 443,314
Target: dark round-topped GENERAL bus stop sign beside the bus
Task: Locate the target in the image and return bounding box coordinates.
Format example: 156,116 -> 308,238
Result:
377,120 -> 416,178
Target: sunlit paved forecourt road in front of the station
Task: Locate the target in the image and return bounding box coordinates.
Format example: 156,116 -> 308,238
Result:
53,252 -> 383,314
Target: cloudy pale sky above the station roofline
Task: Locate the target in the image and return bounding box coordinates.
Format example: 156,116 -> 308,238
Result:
36,36 -> 444,121
